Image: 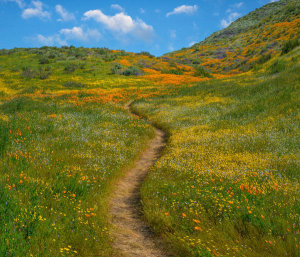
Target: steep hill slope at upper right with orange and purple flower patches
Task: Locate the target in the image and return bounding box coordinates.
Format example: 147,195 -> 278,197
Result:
166,0 -> 300,73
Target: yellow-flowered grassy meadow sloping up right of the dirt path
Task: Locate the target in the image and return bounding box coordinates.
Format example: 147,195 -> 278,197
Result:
134,48 -> 300,257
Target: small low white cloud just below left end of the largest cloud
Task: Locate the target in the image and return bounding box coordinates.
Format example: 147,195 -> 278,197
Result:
59,27 -> 101,41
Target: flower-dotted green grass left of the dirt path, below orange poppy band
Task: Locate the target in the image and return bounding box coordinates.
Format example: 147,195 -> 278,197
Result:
0,97 -> 153,256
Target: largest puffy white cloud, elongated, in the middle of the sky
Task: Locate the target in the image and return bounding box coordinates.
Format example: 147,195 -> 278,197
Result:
83,10 -> 154,41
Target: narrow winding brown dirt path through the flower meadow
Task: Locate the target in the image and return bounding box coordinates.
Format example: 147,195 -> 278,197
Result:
110,102 -> 169,257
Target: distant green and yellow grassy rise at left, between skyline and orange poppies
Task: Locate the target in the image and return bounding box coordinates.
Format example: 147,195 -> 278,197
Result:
0,47 -> 152,93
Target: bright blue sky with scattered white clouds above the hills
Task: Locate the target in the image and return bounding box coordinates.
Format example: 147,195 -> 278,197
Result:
0,0 -> 276,55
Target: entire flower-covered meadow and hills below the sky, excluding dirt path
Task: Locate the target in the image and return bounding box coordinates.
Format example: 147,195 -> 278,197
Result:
0,0 -> 300,257
